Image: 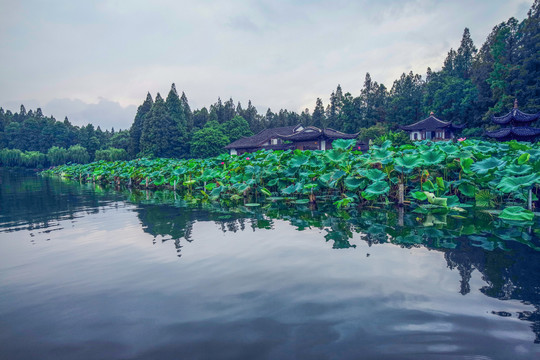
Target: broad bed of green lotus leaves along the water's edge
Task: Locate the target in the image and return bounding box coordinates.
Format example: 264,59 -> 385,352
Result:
45,140 -> 540,221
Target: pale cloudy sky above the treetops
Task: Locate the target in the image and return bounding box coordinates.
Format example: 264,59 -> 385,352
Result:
0,0 -> 533,130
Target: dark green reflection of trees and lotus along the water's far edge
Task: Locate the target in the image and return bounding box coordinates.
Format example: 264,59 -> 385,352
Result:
0,172 -> 540,352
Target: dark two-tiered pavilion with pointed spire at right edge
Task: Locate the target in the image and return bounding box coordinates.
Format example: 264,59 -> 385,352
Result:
485,99 -> 540,142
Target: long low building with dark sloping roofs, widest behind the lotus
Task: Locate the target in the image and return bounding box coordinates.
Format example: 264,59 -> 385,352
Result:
225,125 -> 367,155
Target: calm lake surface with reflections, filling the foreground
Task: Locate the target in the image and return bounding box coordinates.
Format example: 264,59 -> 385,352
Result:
0,170 -> 540,359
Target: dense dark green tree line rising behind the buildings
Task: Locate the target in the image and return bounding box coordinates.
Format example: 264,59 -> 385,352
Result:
0,0 -> 540,160
